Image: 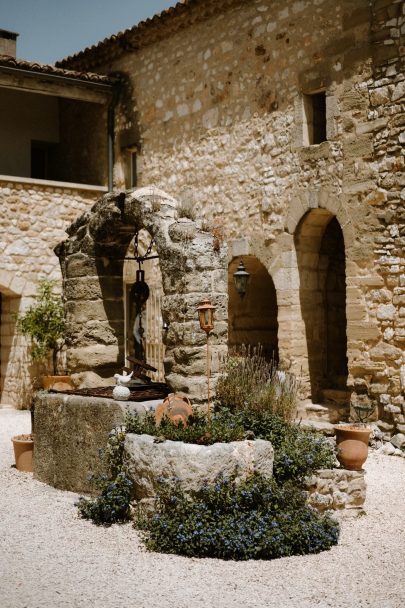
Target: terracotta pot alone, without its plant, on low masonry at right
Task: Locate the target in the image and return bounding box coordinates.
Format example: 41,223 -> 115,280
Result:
334,424 -> 371,471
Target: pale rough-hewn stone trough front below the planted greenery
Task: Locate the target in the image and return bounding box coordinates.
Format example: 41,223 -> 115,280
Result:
125,433 -> 274,500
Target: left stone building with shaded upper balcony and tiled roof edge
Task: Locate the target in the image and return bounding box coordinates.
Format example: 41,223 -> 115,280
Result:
0,30 -> 113,407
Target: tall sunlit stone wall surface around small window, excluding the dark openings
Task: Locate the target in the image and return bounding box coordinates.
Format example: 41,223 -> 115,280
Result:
76,0 -> 405,434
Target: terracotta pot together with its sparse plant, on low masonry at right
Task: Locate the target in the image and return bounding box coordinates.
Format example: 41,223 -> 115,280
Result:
334,404 -> 375,471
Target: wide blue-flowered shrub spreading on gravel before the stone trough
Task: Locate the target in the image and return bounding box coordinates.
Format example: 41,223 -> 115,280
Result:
135,475 -> 339,560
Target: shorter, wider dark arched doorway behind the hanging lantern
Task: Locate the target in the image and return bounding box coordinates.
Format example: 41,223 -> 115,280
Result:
228,255 -> 278,362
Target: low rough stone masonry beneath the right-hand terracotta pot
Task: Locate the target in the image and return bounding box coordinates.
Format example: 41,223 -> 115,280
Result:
306,469 -> 366,511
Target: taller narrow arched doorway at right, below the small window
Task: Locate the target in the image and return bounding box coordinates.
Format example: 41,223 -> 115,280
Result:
294,209 -> 348,403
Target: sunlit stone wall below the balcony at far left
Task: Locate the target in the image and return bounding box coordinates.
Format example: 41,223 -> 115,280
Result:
0,178 -> 105,407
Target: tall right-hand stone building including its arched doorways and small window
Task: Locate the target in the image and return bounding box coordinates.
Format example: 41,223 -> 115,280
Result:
0,0 -> 405,432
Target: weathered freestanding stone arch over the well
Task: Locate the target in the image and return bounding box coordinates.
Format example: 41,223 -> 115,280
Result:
55,188 -> 227,400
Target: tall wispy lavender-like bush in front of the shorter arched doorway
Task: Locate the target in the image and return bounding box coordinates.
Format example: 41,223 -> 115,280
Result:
216,347 -> 298,421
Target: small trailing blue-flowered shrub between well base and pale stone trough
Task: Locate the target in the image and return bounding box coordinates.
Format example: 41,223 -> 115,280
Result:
76,428 -> 133,526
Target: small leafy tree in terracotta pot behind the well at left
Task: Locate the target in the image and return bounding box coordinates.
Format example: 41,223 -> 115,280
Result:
16,279 -> 71,389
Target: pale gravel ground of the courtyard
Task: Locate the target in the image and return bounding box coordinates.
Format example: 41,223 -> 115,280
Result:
0,410 -> 405,608
